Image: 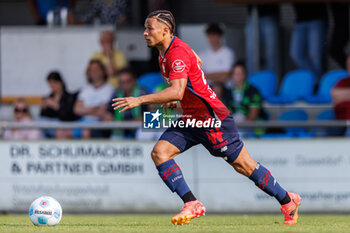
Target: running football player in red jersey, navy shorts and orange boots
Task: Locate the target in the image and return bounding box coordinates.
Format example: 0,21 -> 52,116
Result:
112,10 -> 301,225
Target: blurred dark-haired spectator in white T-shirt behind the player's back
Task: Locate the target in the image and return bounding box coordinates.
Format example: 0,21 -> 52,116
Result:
199,24 -> 235,83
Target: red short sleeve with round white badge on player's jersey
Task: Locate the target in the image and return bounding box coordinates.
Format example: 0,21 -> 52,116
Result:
167,48 -> 191,81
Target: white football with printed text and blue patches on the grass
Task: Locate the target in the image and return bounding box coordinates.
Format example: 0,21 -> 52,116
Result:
29,196 -> 62,226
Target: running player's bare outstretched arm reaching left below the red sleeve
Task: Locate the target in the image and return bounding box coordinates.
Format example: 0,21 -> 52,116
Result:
112,78 -> 187,112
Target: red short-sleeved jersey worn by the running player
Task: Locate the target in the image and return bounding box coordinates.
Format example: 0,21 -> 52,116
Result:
159,36 -> 230,121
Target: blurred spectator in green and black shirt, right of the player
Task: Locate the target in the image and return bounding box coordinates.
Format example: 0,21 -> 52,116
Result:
225,62 -> 266,122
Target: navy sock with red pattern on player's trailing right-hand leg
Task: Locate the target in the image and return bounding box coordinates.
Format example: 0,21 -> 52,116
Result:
249,163 -> 290,205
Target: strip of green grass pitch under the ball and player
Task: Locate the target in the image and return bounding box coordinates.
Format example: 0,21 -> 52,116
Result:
0,214 -> 350,233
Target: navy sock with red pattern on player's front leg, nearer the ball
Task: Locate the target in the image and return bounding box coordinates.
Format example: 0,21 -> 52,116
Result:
157,159 -> 194,202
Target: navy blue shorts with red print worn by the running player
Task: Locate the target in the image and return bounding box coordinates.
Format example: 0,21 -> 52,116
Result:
159,115 -> 243,163
